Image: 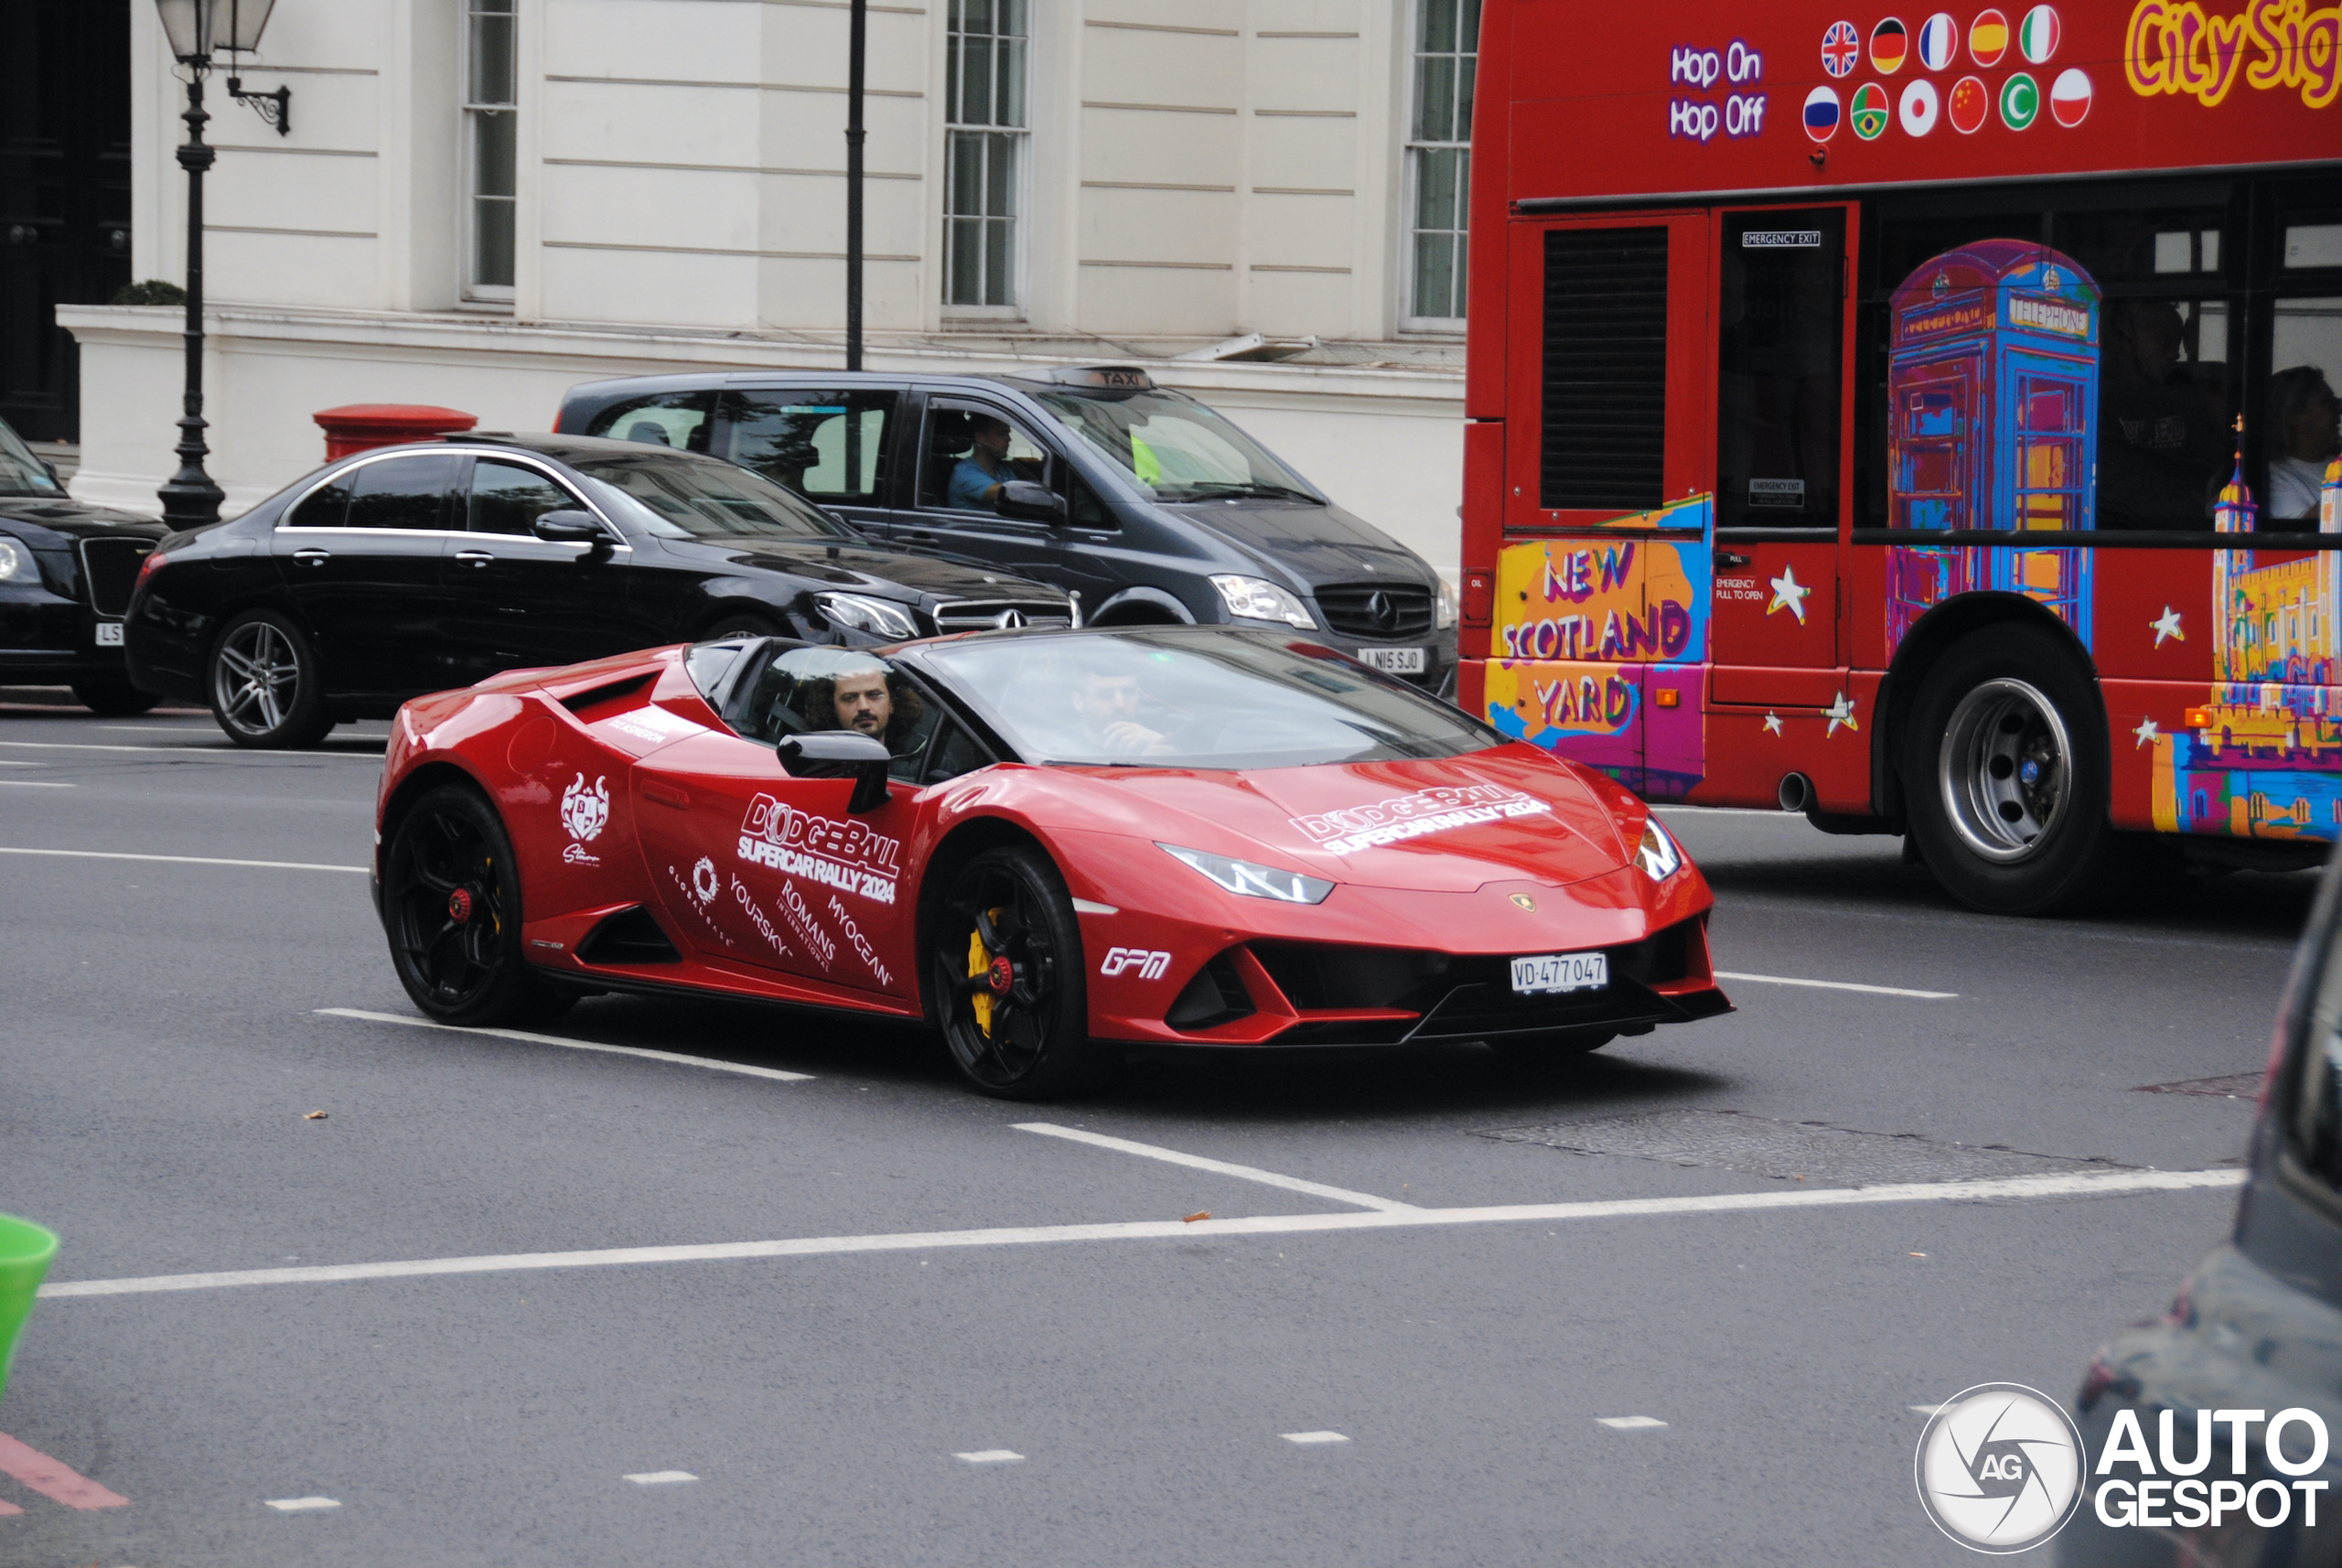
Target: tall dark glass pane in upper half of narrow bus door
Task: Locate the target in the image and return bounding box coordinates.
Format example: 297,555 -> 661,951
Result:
1716,206 -> 1845,527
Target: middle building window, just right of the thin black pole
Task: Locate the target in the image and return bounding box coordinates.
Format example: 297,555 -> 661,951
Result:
944,0 -> 1026,306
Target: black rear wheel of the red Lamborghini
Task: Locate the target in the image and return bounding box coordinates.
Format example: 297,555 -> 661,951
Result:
381,784 -> 574,1025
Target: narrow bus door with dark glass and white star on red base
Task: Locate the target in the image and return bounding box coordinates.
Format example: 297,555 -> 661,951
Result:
1710,206 -> 1853,709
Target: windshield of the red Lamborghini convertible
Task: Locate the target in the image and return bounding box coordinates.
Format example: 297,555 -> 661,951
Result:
920,628 -> 1504,768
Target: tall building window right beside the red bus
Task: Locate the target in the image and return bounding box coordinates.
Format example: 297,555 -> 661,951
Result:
1408,0 -> 1480,326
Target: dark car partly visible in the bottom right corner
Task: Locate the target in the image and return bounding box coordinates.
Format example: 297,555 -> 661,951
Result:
2058,859 -> 2342,1568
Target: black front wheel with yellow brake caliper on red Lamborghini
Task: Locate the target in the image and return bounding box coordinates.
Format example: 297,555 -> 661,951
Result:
928,845 -> 1101,1100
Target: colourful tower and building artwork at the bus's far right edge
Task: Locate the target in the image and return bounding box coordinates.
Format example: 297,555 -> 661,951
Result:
2153,428 -> 2342,838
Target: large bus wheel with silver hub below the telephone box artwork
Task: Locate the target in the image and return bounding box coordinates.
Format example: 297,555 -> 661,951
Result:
1902,628 -> 2115,915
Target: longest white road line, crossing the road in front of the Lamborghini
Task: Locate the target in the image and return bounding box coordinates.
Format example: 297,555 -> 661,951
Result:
40,1165 -> 2246,1301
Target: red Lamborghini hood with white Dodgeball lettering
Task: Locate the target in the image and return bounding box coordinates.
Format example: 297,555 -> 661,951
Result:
1051,745 -> 1628,892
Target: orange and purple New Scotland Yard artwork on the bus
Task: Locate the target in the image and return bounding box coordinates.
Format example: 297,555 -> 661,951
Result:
1488,496 -> 1716,800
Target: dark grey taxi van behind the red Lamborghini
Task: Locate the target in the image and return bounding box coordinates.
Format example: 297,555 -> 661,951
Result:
555,365 -> 1456,691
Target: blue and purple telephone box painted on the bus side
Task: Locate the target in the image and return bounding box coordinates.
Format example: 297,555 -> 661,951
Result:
1887,239 -> 2099,650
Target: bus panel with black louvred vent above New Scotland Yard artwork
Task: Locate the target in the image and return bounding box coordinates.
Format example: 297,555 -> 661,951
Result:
1485,213 -> 1712,798
